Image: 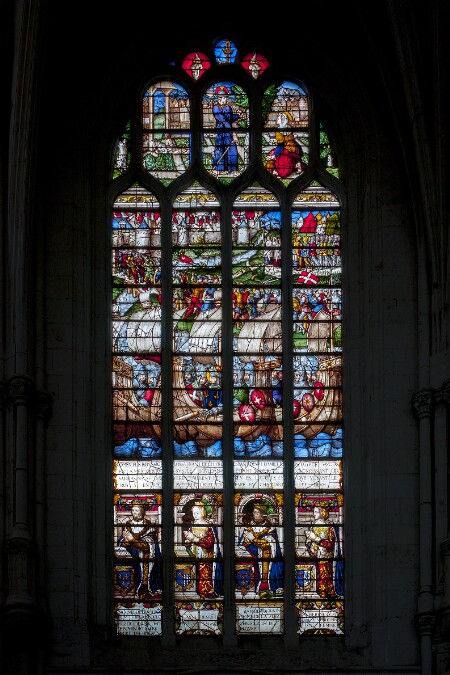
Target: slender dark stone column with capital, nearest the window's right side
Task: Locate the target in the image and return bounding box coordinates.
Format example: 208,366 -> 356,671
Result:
412,389 -> 435,675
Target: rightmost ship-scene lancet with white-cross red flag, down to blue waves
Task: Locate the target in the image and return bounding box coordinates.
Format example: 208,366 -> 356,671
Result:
292,183 -> 342,458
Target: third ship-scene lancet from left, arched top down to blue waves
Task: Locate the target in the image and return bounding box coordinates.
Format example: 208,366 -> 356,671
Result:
232,184 -> 283,458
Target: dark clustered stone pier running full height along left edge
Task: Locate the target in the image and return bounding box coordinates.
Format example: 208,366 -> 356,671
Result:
0,0 -> 48,675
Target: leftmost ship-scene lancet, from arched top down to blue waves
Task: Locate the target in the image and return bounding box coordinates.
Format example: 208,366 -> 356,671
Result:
112,186 -> 162,458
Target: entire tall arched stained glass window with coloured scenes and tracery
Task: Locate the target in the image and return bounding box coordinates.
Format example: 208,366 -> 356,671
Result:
111,36 -> 345,639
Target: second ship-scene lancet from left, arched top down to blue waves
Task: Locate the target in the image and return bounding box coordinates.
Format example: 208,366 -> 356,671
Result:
172,184 -> 223,458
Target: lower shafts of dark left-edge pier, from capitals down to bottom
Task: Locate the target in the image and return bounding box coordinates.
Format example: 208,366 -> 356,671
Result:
0,376 -> 50,675
